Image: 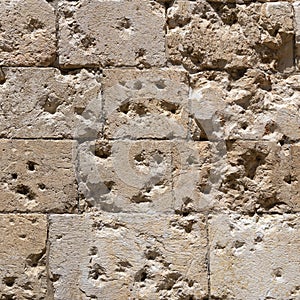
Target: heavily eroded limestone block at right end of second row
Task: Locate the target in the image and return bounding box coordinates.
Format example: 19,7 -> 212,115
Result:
190,69 -> 300,143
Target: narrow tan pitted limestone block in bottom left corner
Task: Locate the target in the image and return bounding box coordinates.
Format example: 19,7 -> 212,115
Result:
0,214 -> 47,300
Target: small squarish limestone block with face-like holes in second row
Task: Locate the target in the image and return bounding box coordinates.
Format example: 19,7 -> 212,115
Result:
103,69 -> 189,139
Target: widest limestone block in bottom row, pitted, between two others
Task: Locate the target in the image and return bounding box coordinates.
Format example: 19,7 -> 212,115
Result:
49,214 -> 208,300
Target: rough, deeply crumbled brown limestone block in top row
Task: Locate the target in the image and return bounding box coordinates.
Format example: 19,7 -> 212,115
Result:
167,1 -> 294,72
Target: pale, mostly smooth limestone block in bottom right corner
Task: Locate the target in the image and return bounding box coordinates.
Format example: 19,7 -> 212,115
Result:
209,214 -> 300,300
